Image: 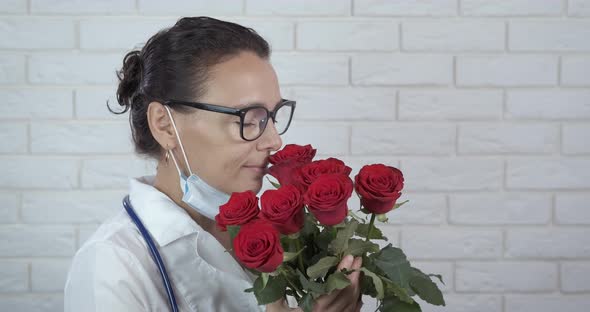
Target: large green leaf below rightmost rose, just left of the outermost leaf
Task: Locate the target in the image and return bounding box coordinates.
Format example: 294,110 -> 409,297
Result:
372,244 -> 412,288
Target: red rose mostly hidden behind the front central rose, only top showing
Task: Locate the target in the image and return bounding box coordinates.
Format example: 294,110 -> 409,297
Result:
293,157 -> 352,193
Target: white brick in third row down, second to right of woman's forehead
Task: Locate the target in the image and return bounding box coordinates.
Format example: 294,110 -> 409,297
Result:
351,54 -> 453,85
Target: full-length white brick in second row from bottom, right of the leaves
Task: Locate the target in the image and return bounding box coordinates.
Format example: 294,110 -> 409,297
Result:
455,261 -> 558,292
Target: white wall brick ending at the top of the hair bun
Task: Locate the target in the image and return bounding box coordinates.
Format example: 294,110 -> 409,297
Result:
28,52 -> 123,84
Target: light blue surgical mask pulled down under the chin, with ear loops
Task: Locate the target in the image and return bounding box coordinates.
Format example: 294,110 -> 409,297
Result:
164,105 -> 230,220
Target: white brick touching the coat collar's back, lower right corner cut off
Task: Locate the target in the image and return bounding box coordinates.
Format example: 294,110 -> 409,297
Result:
22,191 -> 126,223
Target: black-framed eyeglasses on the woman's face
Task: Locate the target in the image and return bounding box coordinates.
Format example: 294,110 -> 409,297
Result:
164,99 -> 296,141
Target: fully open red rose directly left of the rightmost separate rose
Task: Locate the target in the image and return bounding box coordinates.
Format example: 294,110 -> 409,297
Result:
303,173 -> 353,225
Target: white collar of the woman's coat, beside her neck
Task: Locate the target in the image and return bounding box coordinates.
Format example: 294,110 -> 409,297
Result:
129,175 -> 203,246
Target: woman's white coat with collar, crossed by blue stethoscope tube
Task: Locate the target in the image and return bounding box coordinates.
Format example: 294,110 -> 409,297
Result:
64,176 -> 265,312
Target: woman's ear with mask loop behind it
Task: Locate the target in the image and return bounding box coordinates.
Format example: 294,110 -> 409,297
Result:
147,101 -> 178,149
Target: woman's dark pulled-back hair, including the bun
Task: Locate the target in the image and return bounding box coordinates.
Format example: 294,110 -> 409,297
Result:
107,16 -> 270,158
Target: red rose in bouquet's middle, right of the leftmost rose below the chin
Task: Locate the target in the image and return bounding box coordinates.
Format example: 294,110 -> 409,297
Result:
260,185 -> 305,235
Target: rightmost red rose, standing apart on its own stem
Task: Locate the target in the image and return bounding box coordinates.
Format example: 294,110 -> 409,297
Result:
355,164 -> 404,214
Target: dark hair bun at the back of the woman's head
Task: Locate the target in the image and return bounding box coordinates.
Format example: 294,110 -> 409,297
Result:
117,50 -> 143,113
